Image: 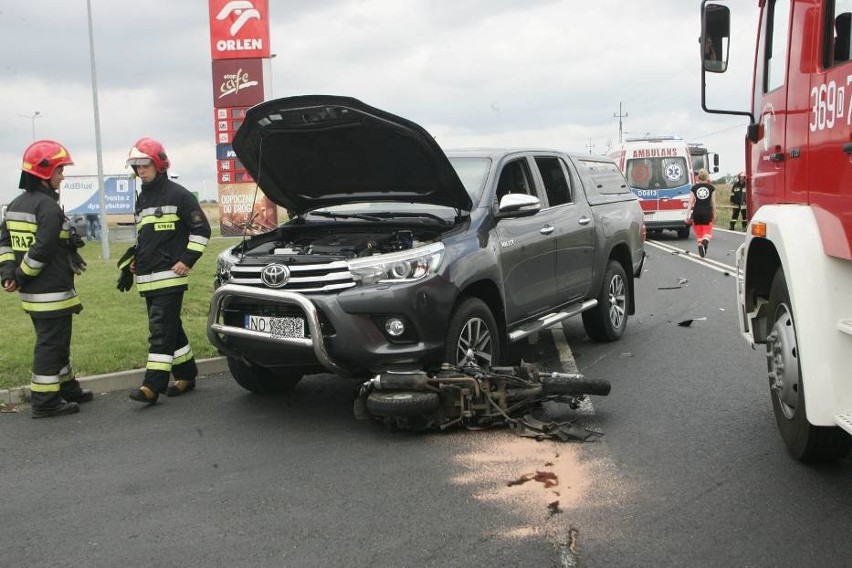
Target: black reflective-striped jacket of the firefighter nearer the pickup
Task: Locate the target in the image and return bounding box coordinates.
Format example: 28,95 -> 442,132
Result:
135,174 -> 210,296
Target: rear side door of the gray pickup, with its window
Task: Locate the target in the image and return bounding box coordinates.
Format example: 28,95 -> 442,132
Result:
535,156 -> 595,305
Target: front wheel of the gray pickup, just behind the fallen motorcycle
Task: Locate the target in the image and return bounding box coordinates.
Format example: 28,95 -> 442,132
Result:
445,298 -> 500,368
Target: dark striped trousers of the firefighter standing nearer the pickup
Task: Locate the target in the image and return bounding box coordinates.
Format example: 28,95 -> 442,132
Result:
142,291 -> 198,394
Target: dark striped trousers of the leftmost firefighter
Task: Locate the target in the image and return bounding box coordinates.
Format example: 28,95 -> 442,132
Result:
30,314 -> 86,410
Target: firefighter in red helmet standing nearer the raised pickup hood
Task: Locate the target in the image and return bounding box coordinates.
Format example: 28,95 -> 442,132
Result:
119,138 -> 210,404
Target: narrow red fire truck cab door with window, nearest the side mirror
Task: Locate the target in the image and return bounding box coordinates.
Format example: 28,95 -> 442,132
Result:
751,0 -> 801,209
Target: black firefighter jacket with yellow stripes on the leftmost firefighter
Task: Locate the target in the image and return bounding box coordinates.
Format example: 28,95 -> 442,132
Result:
0,187 -> 83,318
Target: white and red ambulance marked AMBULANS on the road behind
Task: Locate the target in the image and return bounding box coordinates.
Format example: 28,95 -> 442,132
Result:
608,136 -> 695,239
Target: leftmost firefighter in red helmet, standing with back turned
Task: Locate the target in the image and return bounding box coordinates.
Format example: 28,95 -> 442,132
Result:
0,140 -> 93,418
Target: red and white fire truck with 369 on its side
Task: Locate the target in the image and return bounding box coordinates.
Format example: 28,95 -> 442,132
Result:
700,0 -> 852,462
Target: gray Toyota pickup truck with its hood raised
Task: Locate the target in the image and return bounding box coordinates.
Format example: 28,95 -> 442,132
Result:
208,95 -> 645,392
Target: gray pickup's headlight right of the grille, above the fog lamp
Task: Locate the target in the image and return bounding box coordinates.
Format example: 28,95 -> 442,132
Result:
349,243 -> 444,284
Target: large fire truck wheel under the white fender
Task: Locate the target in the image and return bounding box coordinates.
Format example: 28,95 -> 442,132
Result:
766,268 -> 850,462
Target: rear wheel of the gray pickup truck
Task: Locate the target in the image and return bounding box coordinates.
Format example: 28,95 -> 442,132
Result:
583,260 -> 627,342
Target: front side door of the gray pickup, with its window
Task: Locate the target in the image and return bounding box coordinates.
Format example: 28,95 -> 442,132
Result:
494,157 -> 556,324
